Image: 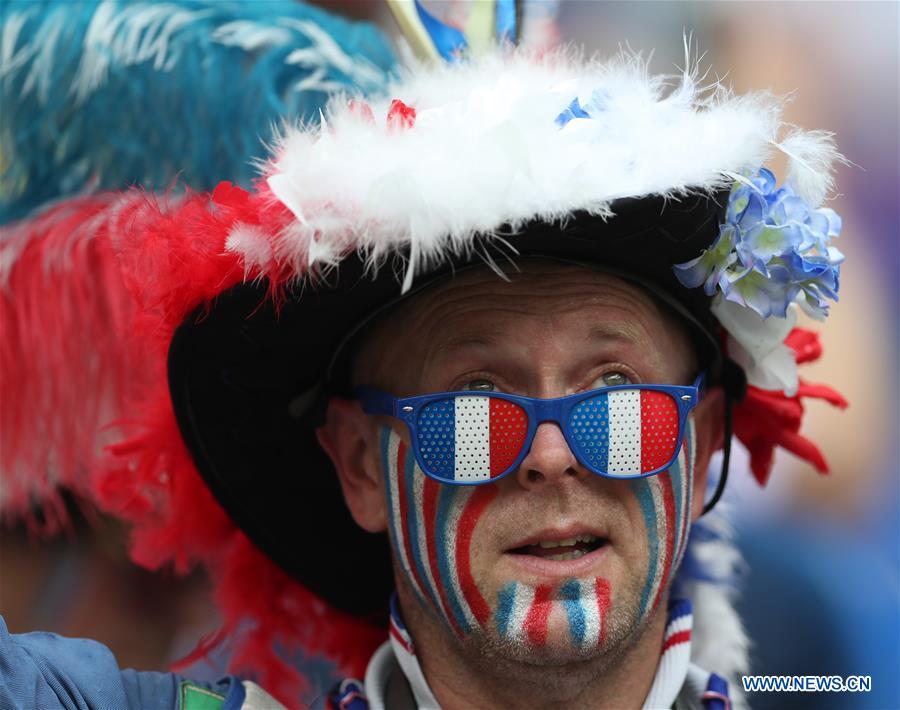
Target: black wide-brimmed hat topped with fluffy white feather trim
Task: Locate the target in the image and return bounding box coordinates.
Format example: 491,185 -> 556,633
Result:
163,54 -> 835,613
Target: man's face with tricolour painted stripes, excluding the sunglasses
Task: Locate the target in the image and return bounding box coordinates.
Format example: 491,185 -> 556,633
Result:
348,262 -> 708,663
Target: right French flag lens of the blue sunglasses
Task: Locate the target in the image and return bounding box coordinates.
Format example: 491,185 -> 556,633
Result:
569,389 -> 678,476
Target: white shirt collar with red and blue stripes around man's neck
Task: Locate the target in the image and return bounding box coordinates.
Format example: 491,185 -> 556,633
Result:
365,596 -> 696,710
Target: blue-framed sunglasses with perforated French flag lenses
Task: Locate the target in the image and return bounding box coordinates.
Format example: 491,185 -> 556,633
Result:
356,373 -> 703,485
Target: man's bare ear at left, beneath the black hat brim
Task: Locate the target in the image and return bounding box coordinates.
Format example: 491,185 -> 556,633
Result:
316,397 -> 387,533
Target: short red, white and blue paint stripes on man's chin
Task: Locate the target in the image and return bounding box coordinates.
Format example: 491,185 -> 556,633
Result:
496,577 -> 609,648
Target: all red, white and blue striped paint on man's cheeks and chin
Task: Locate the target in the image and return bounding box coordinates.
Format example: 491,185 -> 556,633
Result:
380,422 -> 694,649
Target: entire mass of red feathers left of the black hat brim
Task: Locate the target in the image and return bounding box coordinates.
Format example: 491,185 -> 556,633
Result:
0,183 -> 385,706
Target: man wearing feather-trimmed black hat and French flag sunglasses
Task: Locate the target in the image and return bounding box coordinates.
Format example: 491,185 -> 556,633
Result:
3,6 -> 841,708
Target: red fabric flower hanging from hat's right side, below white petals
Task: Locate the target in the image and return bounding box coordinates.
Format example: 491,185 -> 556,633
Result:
734,328 -> 847,486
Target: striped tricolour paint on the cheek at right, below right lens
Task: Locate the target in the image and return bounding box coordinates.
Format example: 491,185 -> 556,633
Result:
631,419 -> 695,619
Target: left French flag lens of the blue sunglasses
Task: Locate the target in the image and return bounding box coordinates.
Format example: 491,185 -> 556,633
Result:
416,395 -> 528,483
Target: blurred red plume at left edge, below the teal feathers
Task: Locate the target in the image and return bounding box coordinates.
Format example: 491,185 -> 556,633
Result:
0,193 -> 151,534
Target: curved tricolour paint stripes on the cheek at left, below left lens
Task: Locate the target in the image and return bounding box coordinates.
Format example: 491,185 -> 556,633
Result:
379,427 -> 497,636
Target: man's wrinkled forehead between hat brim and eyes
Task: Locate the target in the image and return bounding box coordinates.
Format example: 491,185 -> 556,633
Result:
348,259 -> 684,390
